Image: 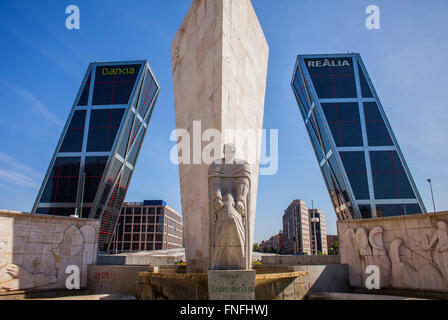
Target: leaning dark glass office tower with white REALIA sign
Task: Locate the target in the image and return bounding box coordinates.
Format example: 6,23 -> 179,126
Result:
291,54 -> 426,220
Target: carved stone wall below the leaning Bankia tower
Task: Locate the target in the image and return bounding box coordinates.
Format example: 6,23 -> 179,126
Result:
0,211 -> 99,295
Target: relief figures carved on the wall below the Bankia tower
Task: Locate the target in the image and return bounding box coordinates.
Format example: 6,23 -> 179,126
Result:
0,225 -> 96,291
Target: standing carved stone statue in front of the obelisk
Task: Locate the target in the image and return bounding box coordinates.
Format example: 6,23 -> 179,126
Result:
209,144 -> 251,270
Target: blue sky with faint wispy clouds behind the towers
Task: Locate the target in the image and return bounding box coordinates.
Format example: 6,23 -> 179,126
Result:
0,0 -> 448,242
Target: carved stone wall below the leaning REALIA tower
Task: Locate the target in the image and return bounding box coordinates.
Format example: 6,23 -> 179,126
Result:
337,212 -> 448,292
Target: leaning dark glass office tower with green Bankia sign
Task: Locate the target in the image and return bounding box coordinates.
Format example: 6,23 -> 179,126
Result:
32,61 -> 160,251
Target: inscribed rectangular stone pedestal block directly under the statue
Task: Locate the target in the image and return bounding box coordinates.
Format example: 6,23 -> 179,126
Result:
207,270 -> 256,300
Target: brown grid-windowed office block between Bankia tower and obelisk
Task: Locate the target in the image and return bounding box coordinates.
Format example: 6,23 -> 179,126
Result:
108,200 -> 183,254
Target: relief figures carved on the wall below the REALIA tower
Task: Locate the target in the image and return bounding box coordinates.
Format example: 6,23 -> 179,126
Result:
341,221 -> 448,291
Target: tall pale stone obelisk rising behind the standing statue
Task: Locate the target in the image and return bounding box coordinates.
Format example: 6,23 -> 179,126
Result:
171,0 -> 269,272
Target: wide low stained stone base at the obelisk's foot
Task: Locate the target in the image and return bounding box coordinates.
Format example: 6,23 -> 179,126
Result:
140,269 -> 310,300
